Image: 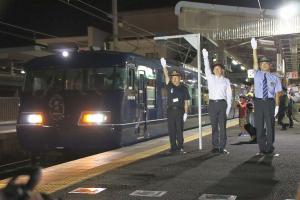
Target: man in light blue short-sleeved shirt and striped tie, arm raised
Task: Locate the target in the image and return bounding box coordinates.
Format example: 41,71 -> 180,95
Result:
251,38 -> 282,155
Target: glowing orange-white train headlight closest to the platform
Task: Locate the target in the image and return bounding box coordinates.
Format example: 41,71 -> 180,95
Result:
78,111 -> 109,126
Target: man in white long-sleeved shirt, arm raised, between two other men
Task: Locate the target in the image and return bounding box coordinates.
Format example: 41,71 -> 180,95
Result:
202,49 -> 232,154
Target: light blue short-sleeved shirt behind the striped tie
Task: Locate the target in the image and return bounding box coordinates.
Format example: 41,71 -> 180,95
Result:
254,70 -> 282,98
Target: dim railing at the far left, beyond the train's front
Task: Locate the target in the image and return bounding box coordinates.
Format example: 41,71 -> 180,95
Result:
0,97 -> 20,122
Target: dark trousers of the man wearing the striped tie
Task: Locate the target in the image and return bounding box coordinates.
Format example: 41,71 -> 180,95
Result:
254,99 -> 275,152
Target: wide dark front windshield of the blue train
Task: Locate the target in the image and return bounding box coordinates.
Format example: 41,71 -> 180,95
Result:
24,67 -> 126,95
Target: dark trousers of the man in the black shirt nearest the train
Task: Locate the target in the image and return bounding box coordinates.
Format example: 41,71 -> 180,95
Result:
168,109 -> 184,151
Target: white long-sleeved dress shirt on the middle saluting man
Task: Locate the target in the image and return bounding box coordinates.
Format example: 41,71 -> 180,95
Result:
204,58 -> 232,111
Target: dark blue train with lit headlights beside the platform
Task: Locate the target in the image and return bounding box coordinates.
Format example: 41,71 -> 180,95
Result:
17,51 -> 237,152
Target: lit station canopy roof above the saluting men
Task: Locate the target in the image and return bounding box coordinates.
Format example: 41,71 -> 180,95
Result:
175,1 -> 300,71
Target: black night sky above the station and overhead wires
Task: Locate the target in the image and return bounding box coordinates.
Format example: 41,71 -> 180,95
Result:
0,0 -> 287,48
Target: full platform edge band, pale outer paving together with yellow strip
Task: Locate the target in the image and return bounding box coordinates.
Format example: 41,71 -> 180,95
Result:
0,120 -> 238,194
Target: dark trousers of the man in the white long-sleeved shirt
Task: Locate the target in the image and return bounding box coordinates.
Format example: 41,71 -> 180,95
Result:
208,100 -> 227,150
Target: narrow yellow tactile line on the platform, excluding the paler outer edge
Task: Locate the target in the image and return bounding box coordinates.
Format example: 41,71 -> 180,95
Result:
0,120 -> 238,194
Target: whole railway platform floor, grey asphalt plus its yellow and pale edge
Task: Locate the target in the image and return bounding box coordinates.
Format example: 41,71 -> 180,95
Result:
0,120 -> 300,200
